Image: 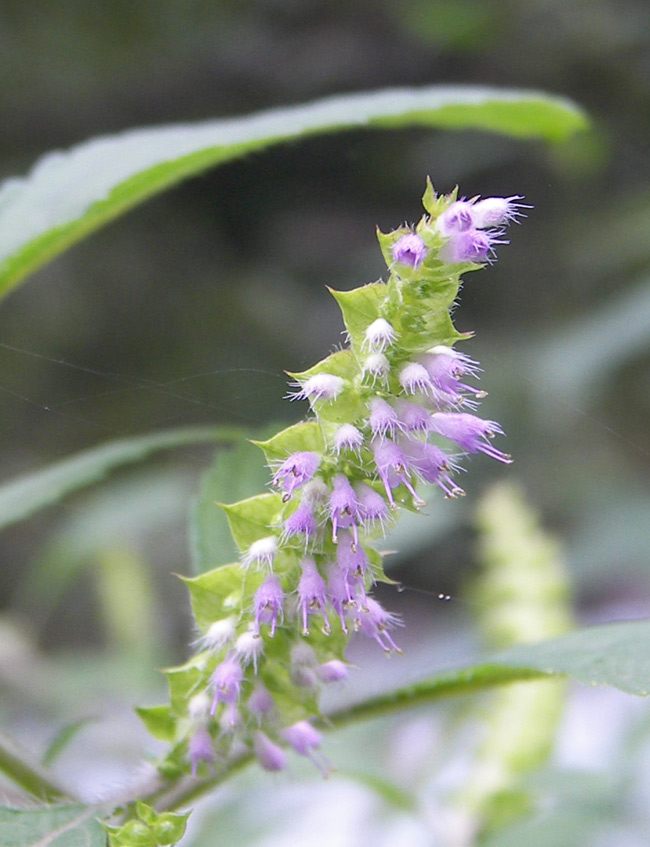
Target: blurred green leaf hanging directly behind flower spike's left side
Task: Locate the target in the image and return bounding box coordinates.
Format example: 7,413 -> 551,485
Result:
190,443 -> 269,574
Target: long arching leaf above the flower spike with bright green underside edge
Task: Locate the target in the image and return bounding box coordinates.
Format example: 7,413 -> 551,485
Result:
0,85 -> 587,294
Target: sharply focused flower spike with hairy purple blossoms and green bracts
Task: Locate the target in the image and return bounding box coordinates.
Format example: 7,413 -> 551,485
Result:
143,183 -> 526,775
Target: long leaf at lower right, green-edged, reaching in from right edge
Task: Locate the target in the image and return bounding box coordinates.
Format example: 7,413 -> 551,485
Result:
328,620 -> 650,725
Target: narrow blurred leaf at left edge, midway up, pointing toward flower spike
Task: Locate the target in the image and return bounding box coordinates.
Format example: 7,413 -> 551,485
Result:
0,426 -> 243,529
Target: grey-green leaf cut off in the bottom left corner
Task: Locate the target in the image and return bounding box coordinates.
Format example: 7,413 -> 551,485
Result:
0,805 -> 106,847
